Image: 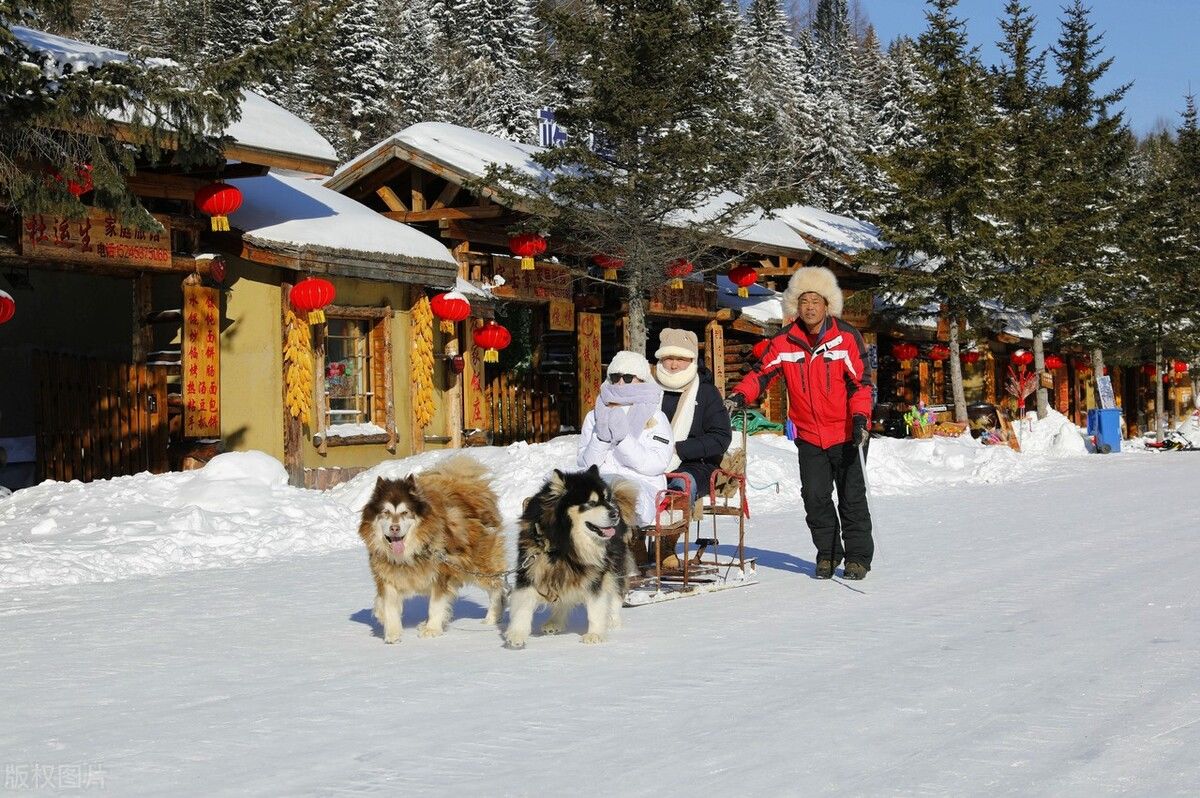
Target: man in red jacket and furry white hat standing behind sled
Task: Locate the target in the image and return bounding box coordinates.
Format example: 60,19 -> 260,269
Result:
726,266 -> 875,580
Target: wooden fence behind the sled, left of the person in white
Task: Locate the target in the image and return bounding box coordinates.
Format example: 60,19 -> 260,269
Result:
484,372 -> 576,446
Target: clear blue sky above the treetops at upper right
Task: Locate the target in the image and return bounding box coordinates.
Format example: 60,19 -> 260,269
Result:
860,0 -> 1200,133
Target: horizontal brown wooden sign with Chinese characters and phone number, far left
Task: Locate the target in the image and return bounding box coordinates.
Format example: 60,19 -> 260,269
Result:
20,209 -> 170,269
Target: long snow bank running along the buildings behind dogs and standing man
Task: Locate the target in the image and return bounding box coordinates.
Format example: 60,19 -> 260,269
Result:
0,429 -> 1082,590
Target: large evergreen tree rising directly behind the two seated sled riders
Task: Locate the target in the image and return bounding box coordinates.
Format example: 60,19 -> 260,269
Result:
488,0 -> 796,352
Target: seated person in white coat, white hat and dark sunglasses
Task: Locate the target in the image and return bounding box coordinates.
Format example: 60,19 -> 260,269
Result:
578,350 -> 674,535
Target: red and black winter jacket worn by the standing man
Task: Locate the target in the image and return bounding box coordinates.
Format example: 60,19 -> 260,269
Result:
733,316 -> 874,449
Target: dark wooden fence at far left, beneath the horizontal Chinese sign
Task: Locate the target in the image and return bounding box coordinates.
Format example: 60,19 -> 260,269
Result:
34,352 -> 168,481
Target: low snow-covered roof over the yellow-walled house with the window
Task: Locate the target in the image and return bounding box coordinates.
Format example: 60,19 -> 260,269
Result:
229,173 -> 458,288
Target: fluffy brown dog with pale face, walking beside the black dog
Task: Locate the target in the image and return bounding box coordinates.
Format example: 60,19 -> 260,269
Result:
359,455 -> 505,643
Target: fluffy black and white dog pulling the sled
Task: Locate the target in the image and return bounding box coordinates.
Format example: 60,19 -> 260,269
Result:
504,466 -> 637,648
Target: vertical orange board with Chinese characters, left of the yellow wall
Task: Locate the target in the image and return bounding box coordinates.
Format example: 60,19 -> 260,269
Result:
182,276 -> 221,438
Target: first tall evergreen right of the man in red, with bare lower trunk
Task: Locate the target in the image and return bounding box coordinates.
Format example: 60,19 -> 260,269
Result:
878,0 -> 996,421
